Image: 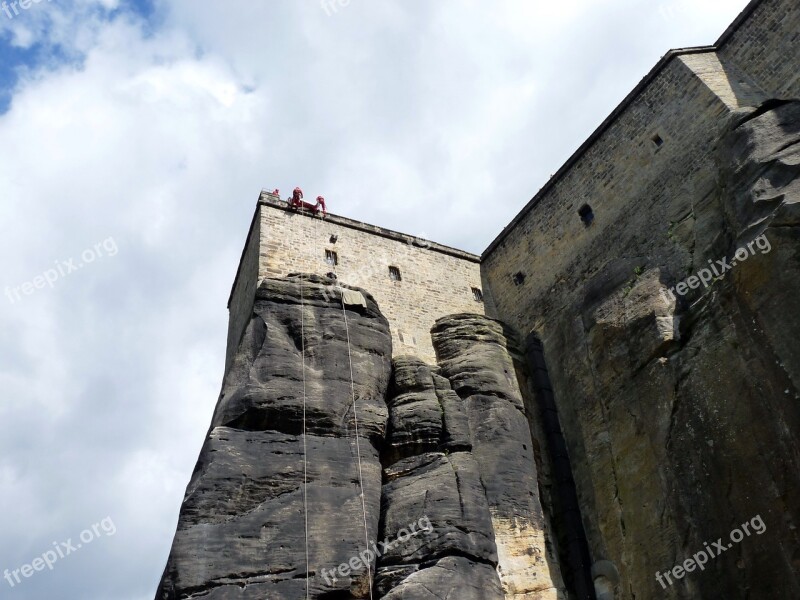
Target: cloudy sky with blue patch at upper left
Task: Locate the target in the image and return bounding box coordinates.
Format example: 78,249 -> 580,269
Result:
0,0 -> 747,600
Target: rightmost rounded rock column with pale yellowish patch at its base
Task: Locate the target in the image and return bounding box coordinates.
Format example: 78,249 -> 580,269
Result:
432,314 -> 559,600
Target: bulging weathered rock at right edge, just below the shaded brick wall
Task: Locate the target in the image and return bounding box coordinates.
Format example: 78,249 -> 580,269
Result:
720,101 -> 800,389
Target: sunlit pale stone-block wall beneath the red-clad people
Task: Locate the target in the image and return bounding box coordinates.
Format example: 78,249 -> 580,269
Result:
228,192 -> 485,362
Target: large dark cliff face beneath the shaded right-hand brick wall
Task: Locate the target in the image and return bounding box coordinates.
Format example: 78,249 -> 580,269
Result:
520,102 -> 800,599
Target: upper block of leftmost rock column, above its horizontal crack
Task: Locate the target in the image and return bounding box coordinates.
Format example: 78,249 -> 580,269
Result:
212,276 -> 391,442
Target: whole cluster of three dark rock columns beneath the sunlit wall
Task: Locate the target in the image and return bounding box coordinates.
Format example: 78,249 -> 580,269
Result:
156,276 -> 563,600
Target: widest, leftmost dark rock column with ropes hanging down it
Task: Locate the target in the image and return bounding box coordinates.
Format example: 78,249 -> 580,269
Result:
156,276 -> 391,600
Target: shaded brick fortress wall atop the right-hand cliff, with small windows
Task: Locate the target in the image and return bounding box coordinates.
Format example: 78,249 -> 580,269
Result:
482,0 -> 800,332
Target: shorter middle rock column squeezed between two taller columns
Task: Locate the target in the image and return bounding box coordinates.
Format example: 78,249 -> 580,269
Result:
376,356 -> 504,600
